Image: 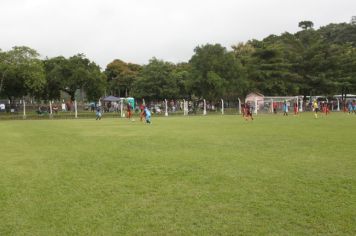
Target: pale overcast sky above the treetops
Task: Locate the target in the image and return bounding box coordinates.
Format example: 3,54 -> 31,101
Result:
0,0 -> 356,68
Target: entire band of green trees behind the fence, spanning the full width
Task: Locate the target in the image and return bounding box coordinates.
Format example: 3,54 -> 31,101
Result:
0,21 -> 356,101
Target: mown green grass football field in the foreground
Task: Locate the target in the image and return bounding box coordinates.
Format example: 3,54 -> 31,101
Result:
0,113 -> 356,235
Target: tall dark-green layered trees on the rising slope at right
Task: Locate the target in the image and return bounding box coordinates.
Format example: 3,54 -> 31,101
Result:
233,22 -> 356,95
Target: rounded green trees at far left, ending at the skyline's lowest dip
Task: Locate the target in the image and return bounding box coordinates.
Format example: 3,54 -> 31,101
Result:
0,47 -> 107,101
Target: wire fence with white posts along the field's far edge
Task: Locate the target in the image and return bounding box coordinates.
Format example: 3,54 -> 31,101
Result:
0,97 -> 350,120
